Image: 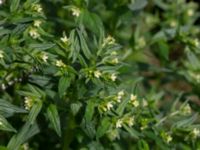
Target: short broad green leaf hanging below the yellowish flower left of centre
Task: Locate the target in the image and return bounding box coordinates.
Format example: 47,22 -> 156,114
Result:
58,76 -> 71,97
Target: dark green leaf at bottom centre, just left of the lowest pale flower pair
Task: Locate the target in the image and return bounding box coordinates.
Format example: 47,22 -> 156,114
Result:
96,117 -> 111,138
